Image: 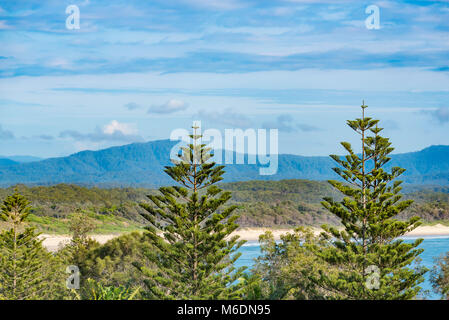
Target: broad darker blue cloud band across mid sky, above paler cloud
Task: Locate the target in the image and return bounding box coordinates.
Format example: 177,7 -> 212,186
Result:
6,48 -> 449,78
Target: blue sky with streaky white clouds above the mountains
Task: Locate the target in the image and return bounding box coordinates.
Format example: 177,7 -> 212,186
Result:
0,0 -> 449,158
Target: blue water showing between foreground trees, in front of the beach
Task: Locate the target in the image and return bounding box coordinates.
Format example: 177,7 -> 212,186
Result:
236,236 -> 449,299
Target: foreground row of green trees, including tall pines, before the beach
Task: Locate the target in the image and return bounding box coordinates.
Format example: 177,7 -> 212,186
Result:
0,105 -> 449,300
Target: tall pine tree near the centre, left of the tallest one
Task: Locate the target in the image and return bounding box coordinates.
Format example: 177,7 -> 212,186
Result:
140,126 -> 245,299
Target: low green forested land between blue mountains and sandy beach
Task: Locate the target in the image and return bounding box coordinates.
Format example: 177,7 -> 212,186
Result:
0,180 -> 449,233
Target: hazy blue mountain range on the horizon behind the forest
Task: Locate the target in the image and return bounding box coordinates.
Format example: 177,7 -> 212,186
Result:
0,140 -> 449,188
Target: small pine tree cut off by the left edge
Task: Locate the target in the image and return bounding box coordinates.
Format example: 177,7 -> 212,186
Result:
0,191 -> 62,300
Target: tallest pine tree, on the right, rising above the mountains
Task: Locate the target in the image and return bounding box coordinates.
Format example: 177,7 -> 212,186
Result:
314,104 -> 426,299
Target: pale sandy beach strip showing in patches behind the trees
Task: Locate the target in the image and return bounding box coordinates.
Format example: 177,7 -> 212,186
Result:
40,224 -> 449,251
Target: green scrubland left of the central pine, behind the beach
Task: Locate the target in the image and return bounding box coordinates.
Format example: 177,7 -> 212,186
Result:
0,184 -> 145,234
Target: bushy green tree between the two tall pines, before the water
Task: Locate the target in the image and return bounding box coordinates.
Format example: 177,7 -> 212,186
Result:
247,227 -> 335,300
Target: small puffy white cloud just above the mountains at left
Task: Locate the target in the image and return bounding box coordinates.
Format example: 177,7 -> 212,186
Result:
59,120 -> 143,142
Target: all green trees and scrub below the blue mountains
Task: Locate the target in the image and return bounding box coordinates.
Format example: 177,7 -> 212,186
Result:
0,110 -> 449,300
